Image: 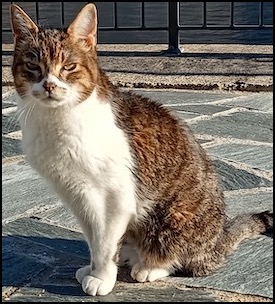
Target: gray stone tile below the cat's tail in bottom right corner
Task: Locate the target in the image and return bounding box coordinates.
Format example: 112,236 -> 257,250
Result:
164,236 -> 273,298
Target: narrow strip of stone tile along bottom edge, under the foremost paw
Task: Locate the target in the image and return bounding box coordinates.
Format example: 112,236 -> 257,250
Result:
4,284 -> 220,303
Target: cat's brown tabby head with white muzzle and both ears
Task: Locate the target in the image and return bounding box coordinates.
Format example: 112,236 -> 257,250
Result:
10,3 -> 98,107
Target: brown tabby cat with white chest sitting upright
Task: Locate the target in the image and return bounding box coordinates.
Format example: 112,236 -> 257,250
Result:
11,4 -> 273,296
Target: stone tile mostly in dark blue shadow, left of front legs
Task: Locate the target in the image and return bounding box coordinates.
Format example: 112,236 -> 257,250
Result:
2,218 -> 89,287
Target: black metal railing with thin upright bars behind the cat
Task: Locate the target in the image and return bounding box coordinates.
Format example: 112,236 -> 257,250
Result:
2,2 -> 273,54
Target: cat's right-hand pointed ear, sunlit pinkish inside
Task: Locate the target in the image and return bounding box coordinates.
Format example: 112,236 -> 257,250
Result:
67,3 -> 97,48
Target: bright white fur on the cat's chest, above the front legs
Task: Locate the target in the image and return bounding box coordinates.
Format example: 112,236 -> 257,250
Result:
16,89 -> 134,204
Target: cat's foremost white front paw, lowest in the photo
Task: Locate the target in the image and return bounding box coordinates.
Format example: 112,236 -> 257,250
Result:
82,275 -> 116,296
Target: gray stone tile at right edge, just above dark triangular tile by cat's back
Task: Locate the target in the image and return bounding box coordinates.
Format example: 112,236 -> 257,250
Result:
208,143 -> 273,170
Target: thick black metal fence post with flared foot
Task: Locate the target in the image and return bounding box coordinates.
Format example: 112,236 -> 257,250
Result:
162,2 -> 181,55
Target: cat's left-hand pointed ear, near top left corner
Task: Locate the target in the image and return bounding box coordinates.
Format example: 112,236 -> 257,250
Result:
10,4 -> 39,38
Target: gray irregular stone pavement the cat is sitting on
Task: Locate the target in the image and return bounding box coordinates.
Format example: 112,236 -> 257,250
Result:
2,89 -> 273,302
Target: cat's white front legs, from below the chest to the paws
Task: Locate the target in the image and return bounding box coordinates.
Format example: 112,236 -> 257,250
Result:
72,189 -> 135,296
